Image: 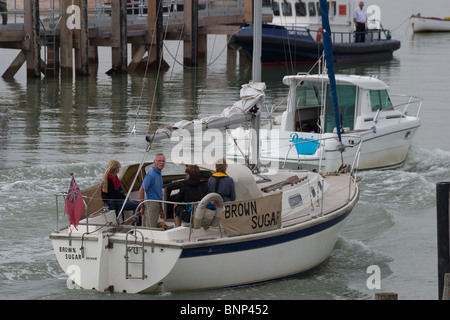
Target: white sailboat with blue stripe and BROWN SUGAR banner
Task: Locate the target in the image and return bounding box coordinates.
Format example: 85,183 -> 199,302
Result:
50,1 -> 359,293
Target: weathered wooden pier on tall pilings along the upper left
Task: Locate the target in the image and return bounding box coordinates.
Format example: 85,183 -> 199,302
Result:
0,0 -> 272,78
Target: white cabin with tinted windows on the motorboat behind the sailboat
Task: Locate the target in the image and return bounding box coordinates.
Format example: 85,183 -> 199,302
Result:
281,75 -> 394,133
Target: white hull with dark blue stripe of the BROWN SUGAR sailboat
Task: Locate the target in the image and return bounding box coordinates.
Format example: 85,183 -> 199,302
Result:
51,197 -> 357,293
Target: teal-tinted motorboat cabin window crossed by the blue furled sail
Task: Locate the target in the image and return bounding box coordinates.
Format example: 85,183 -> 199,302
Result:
325,85 -> 356,132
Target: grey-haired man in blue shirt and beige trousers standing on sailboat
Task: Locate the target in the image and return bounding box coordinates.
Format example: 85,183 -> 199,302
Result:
139,153 -> 166,228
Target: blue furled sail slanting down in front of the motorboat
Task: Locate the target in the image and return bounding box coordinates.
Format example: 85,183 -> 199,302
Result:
320,0 -> 342,141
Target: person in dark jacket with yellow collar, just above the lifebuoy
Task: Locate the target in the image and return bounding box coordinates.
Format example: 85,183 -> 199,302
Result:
208,158 -> 236,202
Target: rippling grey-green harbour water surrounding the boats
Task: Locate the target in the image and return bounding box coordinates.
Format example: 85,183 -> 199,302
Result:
0,0 -> 450,299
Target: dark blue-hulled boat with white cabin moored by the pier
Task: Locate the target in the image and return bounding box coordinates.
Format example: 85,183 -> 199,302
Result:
230,0 -> 401,64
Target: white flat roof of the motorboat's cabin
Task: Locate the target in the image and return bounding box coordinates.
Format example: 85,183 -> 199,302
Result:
283,74 -> 389,90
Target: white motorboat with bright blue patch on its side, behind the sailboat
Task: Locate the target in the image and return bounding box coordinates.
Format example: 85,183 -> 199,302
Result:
228,74 -> 422,172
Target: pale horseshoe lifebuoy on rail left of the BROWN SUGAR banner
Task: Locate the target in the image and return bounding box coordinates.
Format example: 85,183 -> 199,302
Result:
194,192 -> 224,229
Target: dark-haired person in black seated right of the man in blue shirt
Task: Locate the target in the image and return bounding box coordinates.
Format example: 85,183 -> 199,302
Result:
174,164 -> 208,227
